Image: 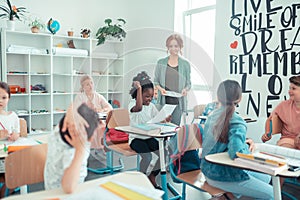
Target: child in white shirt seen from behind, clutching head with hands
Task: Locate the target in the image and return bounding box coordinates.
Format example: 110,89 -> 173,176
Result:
44,102 -> 99,193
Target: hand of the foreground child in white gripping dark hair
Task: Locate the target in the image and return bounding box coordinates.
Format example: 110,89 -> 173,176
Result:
62,104 -> 89,138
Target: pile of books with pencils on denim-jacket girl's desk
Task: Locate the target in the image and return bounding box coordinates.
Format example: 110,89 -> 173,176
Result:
235,143 -> 300,175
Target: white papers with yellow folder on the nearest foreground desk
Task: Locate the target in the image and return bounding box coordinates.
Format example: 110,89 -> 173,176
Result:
62,181 -> 163,200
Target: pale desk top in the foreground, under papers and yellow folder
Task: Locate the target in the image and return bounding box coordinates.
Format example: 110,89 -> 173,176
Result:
5,171 -> 159,200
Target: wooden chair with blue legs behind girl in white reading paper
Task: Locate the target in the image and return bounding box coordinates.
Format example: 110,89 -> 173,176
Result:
88,109 -> 140,174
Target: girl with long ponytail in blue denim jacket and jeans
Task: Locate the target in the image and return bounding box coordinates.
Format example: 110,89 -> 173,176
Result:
201,80 -> 274,199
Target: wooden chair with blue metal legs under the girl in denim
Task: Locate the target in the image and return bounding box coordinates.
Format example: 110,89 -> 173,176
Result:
168,124 -> 231,200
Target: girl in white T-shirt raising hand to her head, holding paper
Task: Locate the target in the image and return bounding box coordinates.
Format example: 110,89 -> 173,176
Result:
128,72 -> 171,189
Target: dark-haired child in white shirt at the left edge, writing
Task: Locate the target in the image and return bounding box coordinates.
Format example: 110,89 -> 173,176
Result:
0,82 -> 20,197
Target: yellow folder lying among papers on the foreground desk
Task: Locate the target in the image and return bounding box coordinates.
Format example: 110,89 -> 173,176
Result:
100,181 -> 153,200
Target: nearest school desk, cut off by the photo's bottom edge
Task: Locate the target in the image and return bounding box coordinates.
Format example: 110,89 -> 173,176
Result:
5,171 -> 162,200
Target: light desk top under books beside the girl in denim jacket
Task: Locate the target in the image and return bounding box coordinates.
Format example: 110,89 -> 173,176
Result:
205,152 -> 300,177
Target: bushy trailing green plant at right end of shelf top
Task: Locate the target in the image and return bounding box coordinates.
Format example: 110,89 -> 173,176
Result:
96,19 -> 126,45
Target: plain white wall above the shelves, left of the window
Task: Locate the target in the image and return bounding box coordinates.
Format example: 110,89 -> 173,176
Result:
0,0 -> 174,106
